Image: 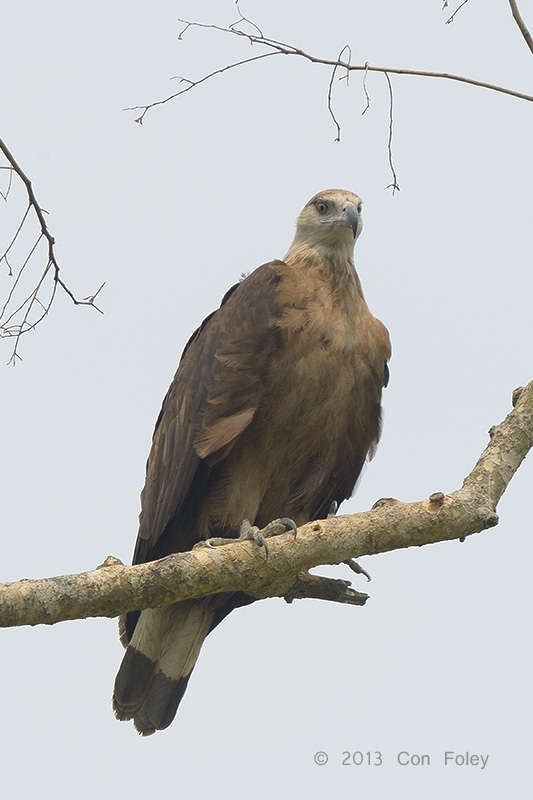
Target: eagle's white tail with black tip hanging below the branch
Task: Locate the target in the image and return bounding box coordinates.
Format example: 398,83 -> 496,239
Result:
113,600 -> 213,736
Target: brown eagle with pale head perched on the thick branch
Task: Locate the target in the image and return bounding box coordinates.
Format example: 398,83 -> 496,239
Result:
113,189 -> 391,736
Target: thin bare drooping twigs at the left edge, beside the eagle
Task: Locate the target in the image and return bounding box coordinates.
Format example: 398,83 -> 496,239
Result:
0,139 -> 104,365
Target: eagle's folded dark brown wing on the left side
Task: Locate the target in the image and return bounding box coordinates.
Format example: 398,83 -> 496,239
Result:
134,261 -> 279,563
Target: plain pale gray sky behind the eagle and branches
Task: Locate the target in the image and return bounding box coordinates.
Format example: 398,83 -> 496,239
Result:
0,0 -> 533,800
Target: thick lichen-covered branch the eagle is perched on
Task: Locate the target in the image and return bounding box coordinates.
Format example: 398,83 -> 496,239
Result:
0,381 -> 533,627
